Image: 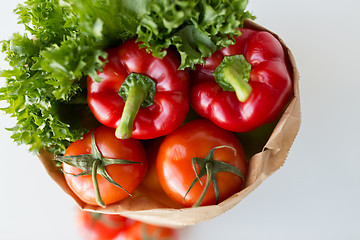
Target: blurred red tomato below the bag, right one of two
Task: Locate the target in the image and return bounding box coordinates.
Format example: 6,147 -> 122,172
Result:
124,221 -> 176,240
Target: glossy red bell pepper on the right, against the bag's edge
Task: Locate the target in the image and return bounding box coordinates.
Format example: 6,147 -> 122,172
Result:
190,28 -> 292,132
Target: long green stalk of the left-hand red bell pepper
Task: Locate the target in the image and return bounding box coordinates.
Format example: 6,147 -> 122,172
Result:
115,86 -> 147,139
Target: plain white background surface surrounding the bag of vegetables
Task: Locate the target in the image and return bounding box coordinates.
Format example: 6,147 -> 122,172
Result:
0,0 -> 360,240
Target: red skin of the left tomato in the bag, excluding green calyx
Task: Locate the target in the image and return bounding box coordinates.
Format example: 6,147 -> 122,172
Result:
63,126 -> 147,206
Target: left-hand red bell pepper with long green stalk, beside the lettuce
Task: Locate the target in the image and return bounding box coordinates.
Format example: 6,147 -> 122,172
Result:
87,40 -> 189,139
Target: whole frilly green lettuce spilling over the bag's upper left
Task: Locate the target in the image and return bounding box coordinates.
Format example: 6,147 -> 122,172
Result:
0,0 -> 252,154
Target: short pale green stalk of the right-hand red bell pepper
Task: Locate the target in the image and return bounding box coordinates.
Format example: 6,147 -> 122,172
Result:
224,65 -> 252,102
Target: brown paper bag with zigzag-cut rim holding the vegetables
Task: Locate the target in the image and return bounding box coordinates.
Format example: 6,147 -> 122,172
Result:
39,21 -> 301,227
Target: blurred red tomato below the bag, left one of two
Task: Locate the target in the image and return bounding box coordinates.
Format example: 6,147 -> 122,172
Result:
76,210 -> 128,240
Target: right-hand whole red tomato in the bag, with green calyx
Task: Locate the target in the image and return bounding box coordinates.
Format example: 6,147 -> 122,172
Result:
156,119 -> 247,207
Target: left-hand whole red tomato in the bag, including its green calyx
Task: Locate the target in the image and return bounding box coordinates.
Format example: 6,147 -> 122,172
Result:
55,126 -> 147,207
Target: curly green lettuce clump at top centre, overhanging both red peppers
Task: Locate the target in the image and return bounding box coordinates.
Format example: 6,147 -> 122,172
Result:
126,0 -> 253,69
